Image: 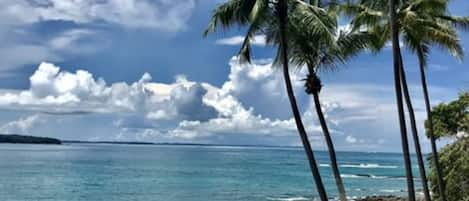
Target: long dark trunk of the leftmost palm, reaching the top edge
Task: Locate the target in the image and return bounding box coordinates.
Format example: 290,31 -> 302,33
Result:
277,0 -> 328,201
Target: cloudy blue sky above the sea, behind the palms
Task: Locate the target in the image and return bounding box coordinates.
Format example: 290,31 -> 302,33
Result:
0,0 -> 469,152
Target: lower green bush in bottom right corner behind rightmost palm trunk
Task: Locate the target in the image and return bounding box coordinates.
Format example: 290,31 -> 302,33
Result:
429,138 -> 469,201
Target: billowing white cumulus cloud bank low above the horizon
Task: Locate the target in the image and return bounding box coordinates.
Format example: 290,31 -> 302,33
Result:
0,58 -> 450,149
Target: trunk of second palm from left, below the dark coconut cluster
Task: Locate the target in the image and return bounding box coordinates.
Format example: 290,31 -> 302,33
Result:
313,92 -> 347,201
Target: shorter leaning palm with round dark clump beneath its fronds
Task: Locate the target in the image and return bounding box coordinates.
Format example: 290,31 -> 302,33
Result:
300,0 -> 376,201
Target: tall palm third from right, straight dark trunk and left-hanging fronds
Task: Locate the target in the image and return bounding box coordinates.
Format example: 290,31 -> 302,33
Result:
341,0 -> 415,201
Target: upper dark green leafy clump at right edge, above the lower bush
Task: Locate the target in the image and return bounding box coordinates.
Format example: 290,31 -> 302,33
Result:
425,92 -> 469,139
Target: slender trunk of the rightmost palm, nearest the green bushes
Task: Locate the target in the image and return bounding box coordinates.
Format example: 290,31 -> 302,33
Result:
419,48 -> 446,201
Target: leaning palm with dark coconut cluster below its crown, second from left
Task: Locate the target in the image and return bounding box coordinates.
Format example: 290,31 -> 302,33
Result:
266,9 -> 374,201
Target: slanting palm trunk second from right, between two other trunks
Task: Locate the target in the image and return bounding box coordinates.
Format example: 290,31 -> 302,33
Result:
399,51 -> 431,201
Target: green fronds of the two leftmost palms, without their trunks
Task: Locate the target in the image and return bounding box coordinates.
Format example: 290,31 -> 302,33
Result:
204,0 -> 377,73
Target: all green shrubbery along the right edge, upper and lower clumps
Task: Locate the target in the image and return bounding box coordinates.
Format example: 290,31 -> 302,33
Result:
425,92 -> 469,201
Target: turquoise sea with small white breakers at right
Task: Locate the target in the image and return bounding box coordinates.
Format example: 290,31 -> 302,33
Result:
0,144 -> 420,201
